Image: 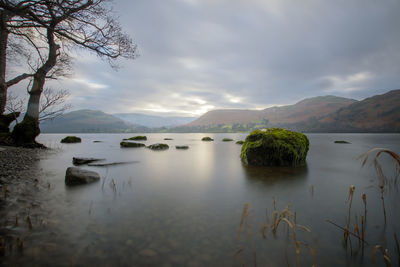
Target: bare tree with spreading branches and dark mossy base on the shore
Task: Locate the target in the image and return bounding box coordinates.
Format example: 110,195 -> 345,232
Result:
0,0 -> 136,147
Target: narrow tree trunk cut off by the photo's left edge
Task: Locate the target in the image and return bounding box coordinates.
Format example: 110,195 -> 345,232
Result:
0,10 -> 10,114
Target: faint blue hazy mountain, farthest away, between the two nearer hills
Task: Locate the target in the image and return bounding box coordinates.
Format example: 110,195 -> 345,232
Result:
113,113 -> 196,128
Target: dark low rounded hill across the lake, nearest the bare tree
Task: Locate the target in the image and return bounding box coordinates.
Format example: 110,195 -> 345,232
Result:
40,109 -> 148,133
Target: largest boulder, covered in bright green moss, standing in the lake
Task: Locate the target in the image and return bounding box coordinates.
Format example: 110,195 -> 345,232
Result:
240,128 -> 310,167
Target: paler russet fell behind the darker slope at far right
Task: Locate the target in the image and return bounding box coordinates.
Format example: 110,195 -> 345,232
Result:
186,96 -> 356,127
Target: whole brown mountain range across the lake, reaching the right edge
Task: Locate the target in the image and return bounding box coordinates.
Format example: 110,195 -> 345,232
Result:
175,90 -> 400,132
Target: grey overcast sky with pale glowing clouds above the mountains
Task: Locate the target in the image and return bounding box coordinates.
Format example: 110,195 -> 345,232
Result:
50,0 -> 400,116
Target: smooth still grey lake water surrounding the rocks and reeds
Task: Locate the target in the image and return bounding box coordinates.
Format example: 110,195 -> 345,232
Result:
3,134 -> 400,266
